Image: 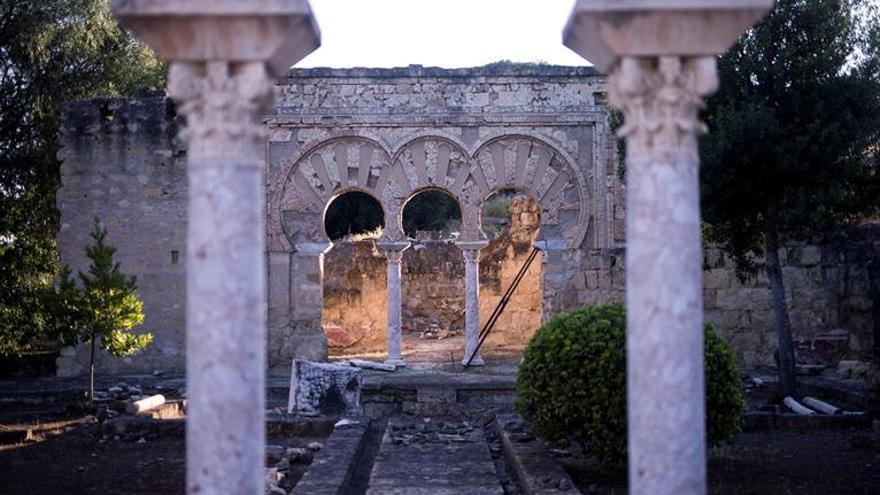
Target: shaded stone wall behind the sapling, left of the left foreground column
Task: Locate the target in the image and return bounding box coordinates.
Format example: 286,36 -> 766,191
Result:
57,97 -> 186,375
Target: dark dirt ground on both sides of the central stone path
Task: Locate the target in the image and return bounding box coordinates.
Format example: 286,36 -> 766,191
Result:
0,374 -> 880,495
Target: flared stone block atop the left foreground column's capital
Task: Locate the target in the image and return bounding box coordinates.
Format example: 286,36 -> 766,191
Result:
113,0 -> 321,76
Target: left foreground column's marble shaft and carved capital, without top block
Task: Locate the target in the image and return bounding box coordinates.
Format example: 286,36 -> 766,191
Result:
169,61 -> 271,495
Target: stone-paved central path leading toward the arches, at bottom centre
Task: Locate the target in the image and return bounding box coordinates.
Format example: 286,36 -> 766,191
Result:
367,417 -> 504,495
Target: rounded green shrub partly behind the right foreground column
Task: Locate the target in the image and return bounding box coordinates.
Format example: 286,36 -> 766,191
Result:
514,304 -> 744,462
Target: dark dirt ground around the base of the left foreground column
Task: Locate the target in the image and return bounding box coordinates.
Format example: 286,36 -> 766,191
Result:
0,406 -> 324,495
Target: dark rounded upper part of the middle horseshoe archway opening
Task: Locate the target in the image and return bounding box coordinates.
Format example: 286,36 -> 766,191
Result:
403,189 -> 461,240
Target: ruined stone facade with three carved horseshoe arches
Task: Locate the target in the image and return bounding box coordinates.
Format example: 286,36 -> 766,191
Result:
267,65 -> 622,364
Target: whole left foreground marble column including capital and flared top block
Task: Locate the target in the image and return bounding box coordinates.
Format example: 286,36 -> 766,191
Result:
114,0 -> 318,495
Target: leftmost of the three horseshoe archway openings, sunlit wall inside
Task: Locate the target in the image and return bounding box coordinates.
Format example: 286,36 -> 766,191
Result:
321,191 -> 387,356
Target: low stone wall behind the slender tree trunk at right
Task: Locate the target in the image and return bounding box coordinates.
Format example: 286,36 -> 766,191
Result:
704,224 -> 880,365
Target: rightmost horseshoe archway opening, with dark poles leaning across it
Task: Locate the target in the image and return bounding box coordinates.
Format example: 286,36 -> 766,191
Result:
480,188 -> 543,355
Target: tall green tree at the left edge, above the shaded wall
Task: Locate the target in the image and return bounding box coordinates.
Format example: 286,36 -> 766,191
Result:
0,0 -> 165,355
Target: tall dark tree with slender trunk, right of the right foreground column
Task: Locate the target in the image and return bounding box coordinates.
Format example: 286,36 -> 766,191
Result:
700,0 -> 880,395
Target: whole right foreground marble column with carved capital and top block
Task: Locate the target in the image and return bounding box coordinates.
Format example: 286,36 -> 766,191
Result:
564,0 -> 772,495
